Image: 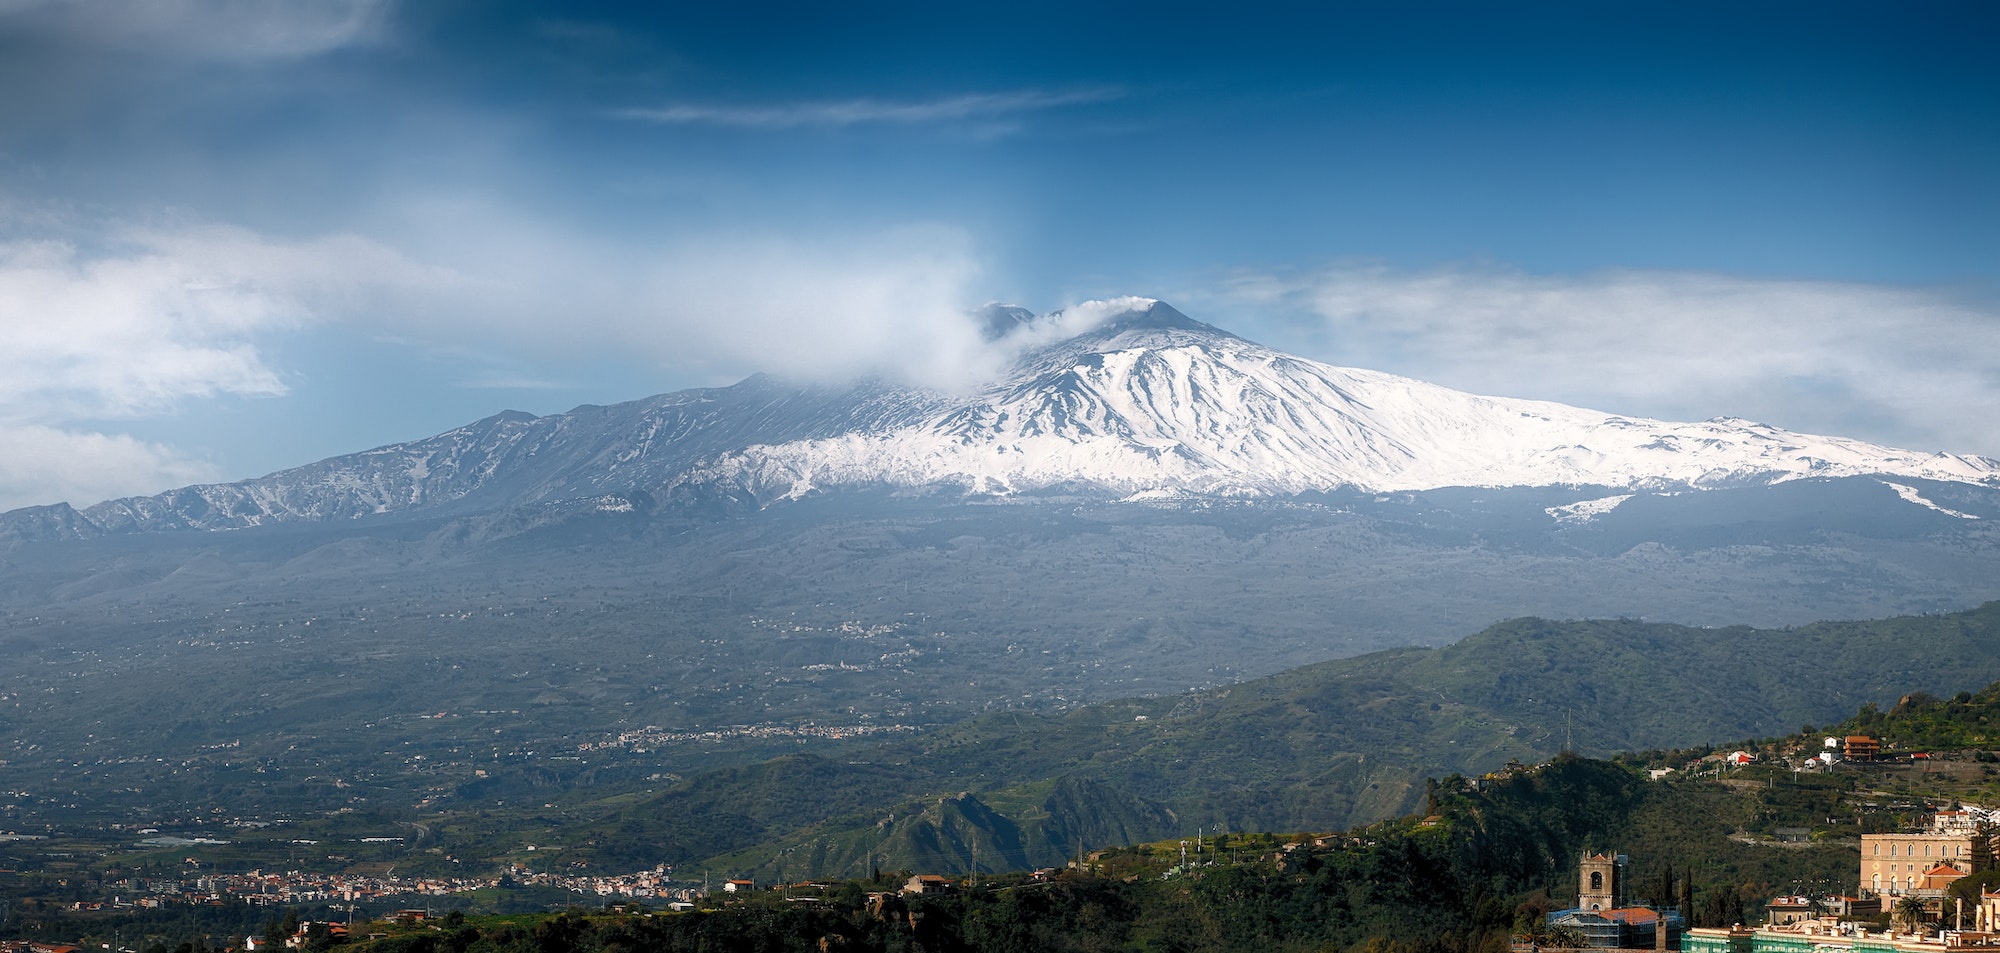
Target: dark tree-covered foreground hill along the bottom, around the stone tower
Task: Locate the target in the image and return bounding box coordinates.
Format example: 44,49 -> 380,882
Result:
324,757 -> 1854,953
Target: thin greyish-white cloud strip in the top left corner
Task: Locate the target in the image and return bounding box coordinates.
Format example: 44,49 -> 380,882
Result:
0,0 -> 390,62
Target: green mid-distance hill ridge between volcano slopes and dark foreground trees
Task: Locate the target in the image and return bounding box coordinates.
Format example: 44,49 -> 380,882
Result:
578,603 -> 2000,877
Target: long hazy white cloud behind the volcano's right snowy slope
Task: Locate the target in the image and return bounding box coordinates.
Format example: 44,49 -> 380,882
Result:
1214,264 -> 2000,456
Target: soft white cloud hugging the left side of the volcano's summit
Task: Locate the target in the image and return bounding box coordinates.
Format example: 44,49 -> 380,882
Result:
352,198 -> 994,388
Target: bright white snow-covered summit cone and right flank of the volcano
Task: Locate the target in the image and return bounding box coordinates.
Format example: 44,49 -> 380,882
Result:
688,298 -> 2000,497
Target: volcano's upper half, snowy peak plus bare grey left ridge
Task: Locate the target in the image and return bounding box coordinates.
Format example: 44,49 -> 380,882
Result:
0,298 -> 2000,539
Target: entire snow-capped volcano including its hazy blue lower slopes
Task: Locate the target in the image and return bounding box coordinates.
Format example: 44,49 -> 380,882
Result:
0,298 -> 2000,864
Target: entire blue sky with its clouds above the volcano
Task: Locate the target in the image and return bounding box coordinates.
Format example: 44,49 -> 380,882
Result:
0,0 -> 2000,507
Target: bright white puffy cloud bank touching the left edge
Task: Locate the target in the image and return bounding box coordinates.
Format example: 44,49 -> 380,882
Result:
0,216 -> 462,507
